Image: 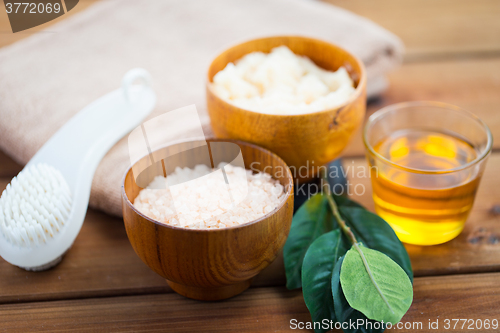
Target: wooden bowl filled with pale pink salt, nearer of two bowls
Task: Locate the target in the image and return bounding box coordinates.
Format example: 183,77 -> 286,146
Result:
122,139 -> 293,300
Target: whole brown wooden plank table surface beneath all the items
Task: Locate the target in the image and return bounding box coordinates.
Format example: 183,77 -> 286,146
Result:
0,0 -> 500,332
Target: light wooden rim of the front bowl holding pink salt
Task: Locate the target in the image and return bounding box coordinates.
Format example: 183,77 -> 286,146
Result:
121,138 -> 294,233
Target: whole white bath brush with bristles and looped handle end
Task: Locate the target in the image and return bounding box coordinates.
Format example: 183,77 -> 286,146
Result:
0,69 -> 156,270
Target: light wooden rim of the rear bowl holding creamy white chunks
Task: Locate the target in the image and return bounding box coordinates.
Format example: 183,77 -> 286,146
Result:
205,35 -> 366,118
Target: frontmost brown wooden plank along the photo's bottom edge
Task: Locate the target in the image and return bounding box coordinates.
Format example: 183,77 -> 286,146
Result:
0,273 -> 500,333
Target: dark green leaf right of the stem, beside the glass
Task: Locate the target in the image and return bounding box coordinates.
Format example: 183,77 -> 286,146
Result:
335,206 -> 413,281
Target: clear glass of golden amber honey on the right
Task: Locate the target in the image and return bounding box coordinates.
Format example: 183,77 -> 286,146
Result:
363,102 -> 493,245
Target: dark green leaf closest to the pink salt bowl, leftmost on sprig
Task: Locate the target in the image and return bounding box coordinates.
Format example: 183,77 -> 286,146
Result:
283,194 -> 337,289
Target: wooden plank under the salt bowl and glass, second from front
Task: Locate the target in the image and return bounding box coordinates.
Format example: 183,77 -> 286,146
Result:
0,153 -> 500,303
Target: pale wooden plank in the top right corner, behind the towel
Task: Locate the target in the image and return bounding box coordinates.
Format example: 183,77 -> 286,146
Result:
326,0 -> 500,61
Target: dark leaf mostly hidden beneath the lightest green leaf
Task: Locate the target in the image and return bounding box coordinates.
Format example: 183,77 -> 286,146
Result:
332,256 -> 385,333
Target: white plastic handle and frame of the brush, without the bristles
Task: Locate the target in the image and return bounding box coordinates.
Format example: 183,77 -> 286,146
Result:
0,69 -> 156,270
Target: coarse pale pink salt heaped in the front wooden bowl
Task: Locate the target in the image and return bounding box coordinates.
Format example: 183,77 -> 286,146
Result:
134,164 -> 286,229
